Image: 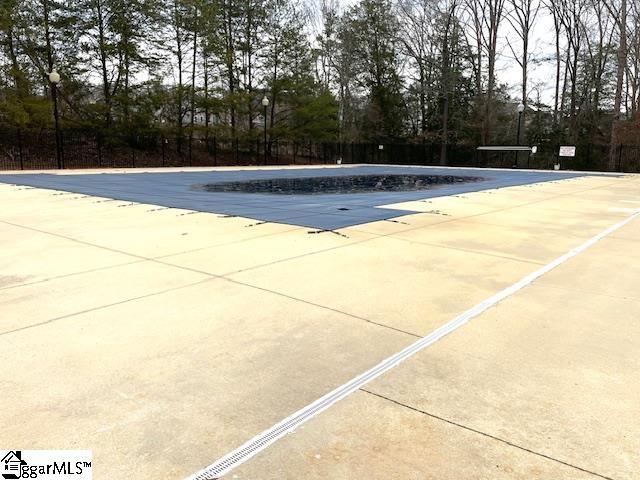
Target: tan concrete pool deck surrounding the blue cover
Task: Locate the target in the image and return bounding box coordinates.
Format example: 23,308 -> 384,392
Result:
0,169 -> 640,480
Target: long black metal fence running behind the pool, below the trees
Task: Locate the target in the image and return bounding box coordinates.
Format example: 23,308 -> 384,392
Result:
0,130 -> 640,172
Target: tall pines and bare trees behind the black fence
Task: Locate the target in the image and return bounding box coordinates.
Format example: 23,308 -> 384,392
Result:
0,0 -> 640,160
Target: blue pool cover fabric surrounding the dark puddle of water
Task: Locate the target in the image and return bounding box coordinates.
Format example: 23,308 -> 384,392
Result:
0,166 -> 585,230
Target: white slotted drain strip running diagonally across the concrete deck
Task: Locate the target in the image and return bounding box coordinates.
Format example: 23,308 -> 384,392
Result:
185,209 -> 640,480
